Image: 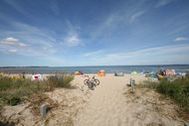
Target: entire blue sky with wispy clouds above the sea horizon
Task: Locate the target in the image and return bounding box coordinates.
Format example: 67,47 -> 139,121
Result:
0,0 -> 189,66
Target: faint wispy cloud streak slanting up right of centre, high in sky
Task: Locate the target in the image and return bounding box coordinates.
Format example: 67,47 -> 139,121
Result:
89,4 -> 149,39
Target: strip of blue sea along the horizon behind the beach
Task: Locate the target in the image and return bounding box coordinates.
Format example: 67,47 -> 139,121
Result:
0,65 -> 189,74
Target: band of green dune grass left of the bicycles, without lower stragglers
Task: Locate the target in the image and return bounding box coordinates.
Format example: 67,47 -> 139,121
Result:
0,75 -> 73,107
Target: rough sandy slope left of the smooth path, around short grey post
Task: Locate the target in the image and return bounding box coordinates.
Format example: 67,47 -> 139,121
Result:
0,75 -> 90,126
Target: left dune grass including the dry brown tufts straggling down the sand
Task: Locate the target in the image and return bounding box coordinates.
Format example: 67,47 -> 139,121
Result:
0,74 -> 73,126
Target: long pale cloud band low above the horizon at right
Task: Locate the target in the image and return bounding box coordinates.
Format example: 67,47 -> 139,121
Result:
83,44 -> 189,65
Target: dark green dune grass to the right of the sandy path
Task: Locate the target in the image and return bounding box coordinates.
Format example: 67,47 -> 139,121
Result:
143,76 -> 189,112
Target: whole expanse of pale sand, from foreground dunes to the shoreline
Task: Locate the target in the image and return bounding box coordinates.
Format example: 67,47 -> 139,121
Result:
2,74 -> 186,126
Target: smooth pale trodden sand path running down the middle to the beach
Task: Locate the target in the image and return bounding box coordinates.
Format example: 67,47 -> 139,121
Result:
75,76 -> 139,126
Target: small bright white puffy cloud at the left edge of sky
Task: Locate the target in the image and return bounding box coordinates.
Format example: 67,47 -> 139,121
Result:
0,37 -> 27,47
